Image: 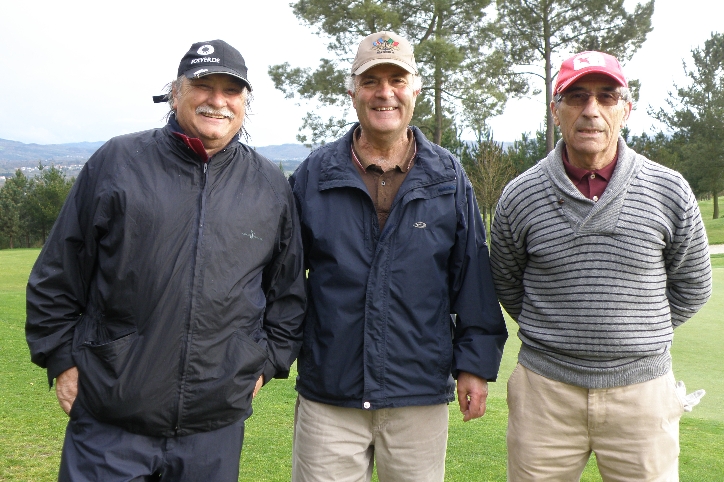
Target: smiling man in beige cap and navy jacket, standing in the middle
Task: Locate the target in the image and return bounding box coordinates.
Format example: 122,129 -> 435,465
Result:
290,32 -> 507,482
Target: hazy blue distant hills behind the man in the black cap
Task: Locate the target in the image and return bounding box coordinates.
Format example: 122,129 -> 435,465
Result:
0,139 -> 310,175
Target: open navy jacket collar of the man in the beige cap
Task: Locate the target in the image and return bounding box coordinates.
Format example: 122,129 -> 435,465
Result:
318,122 -> 455,191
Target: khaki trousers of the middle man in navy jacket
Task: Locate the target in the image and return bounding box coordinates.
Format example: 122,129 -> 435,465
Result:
292,395 -> 448,482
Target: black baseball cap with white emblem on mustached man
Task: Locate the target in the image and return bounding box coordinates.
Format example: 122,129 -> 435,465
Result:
153,40 -> 251,103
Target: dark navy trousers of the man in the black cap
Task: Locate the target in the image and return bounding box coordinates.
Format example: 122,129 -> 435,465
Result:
58,404 -> 246,482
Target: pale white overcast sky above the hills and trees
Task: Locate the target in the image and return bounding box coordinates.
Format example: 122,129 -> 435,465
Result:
0,0 -> 724,146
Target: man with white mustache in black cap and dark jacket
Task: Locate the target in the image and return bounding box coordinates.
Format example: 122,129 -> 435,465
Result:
26,40 -> 305,482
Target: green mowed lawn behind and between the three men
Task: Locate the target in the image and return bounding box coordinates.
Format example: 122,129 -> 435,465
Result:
0,250 -> 724,482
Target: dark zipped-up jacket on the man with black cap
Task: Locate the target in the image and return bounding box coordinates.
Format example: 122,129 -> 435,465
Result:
26,120 -> 305,437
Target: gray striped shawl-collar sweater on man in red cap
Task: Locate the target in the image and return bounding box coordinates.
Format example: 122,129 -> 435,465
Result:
491,138 -> 711,388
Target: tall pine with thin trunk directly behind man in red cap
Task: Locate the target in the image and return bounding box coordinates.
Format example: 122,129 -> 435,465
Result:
496,0 -> 654,152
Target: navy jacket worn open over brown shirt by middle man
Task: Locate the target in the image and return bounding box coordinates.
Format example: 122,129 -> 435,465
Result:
290,125 -> 507,409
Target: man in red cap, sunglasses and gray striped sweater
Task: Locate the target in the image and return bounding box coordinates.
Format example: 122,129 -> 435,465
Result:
491,52 -> 711,481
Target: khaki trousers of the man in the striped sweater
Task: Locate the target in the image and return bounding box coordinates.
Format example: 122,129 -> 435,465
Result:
507,364 -> 684,482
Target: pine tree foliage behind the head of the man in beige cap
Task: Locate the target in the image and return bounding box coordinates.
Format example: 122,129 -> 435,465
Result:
269,0 -> 526,144
